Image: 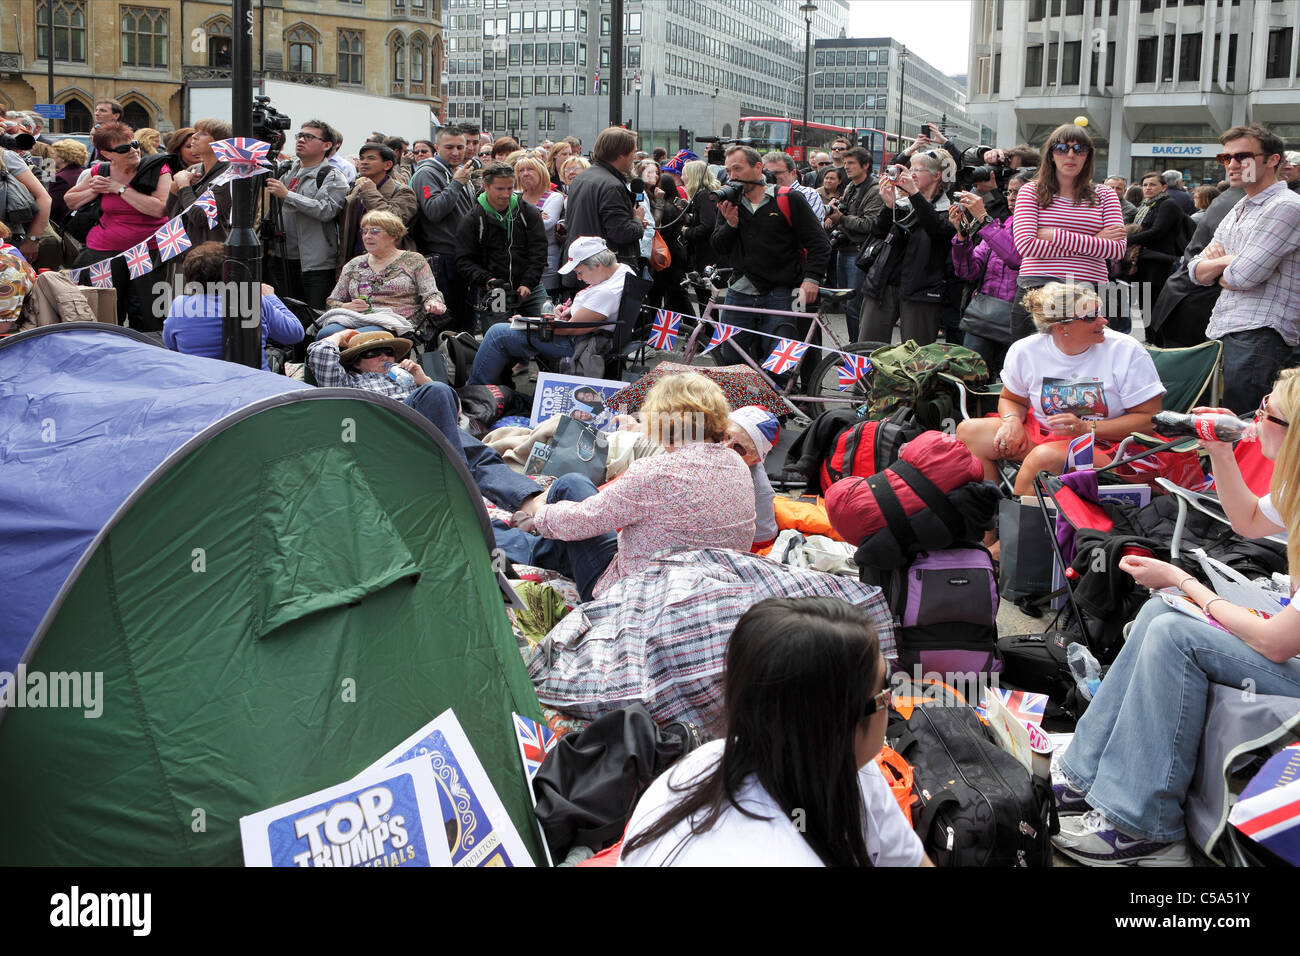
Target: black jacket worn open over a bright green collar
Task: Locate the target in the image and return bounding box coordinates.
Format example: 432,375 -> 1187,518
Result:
456,196 -> 546,290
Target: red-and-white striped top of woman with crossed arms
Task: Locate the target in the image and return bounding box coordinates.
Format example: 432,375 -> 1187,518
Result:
1011,182 -> 1128,285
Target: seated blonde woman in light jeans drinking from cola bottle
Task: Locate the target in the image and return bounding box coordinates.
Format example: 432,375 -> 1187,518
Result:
1052,368 -> 1300,866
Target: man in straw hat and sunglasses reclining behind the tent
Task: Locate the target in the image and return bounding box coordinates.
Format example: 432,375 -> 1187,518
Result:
307,329 -> 541,512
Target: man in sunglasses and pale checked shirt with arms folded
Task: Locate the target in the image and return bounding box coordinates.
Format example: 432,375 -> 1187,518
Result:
1187,124 -> 1300,414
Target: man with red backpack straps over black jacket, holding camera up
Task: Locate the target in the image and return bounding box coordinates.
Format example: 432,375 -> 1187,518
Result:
714,146 -> 831,382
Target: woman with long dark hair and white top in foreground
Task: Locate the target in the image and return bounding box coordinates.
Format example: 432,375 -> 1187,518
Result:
619,597 -> 932,866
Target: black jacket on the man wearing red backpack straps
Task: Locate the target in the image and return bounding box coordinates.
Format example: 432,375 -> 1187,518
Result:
714,186 -> 831,291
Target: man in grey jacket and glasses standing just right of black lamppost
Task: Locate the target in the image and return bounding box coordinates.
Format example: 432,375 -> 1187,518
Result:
267,120 -> 347,310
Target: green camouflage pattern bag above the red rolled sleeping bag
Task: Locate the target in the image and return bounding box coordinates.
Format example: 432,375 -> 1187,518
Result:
866,339 -> 988,432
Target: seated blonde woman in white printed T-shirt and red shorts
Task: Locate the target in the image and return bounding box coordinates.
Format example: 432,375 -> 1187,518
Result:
957,282 -> 1165,494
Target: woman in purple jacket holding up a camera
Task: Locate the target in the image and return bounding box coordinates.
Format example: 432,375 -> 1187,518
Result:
948,170 -> 1034,378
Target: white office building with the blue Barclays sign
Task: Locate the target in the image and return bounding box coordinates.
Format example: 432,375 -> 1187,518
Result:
969,0 -> 1300,183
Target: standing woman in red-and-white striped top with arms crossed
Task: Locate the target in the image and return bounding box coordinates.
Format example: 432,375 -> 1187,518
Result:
1011,122 -> 1127,341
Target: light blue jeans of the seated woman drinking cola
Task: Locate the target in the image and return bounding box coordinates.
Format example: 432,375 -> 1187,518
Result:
1061,598 -> 1300,843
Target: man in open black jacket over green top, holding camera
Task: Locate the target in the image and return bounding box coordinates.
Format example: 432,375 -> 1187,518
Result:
456,163 -> 546,325
